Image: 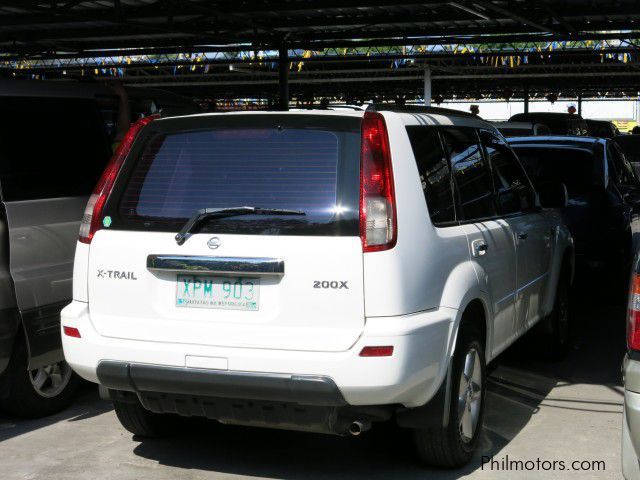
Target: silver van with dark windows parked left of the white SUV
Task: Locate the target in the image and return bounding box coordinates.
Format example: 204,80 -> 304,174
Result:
0,80 -> 198,416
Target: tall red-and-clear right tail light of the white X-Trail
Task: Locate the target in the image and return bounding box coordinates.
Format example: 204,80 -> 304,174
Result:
360,112 -> 398,252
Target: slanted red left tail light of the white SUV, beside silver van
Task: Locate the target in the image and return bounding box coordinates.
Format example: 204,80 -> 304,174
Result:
78,115 -> 159,243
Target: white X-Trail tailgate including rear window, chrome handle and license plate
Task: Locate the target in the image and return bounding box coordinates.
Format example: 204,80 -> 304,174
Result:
89,114 -> 364,351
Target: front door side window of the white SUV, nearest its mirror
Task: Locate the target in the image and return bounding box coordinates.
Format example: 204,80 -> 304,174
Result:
480,131 -> 535,215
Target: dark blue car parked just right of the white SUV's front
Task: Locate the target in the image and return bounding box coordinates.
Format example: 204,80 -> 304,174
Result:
509,137 -> 640,281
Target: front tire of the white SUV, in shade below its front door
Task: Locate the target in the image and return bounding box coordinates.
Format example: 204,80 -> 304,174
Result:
539,273 -> 571,361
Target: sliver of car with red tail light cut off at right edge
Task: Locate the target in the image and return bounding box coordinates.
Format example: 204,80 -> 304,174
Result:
622,256 -> 640,480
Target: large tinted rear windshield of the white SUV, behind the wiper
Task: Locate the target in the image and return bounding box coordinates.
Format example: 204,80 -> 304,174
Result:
108,115 -> 360,235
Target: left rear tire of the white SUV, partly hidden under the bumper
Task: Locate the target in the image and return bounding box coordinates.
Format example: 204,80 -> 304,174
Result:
113,401 -> 179,438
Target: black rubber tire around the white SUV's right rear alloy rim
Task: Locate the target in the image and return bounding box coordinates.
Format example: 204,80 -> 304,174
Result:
413,325 -> 486,468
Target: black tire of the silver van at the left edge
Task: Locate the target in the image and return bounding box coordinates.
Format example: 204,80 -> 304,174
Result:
0,341 -> 80,418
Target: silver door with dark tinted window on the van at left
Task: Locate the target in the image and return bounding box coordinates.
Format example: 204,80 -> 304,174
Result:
0,97 -> 110,315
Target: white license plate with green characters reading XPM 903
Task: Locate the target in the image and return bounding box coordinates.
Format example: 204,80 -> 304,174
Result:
176,275 -> 260,311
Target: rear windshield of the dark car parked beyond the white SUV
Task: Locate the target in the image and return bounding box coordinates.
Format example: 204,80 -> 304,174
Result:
512,145 -> 599,197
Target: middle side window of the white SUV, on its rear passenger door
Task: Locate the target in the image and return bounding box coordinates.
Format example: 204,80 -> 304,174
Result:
441,128 -> 496,220
